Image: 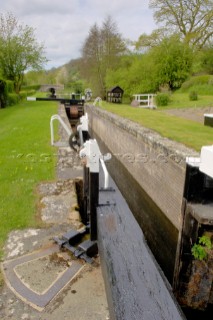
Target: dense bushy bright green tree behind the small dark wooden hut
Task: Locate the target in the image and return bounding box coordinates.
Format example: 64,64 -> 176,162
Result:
106,35 -> 193,97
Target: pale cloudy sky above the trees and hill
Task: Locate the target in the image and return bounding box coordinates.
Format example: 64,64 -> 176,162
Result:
0,0 -> 156,69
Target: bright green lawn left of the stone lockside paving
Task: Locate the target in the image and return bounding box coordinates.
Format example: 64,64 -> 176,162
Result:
0,101 -> 58,264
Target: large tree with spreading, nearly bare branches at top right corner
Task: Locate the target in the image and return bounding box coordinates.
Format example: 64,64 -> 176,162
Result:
149,0 -> 213,48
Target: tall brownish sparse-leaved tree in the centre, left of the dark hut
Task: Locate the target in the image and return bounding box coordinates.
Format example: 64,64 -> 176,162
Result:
81,17 -> 126,97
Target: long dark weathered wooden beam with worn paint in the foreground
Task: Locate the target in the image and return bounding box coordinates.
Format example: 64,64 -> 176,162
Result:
97,169 -> 185,320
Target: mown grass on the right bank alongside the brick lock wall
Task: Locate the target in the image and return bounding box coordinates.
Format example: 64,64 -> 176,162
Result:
101,94 -> 213,151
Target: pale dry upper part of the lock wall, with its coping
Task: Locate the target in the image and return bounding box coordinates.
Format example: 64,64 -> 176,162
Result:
85,106 -> 198,230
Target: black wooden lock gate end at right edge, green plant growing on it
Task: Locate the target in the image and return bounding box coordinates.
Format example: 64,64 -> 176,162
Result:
173,147 -> 213,310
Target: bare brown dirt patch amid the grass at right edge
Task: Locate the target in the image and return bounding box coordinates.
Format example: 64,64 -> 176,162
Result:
165,107 -> 213,123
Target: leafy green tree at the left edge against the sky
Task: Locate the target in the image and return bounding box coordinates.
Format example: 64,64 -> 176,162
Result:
0,13 -> 47,93
